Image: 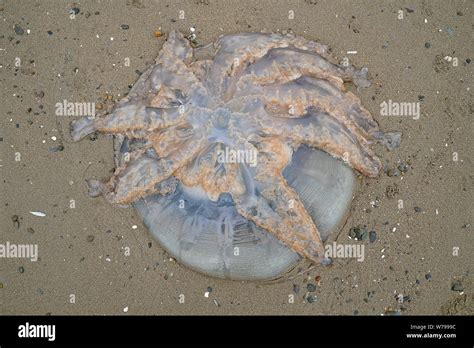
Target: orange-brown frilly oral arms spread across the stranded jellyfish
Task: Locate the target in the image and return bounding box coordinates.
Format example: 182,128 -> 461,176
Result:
73,32 -> 396,262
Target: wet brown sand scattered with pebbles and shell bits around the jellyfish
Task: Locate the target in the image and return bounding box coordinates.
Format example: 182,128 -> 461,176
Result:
0,0 -> 474,315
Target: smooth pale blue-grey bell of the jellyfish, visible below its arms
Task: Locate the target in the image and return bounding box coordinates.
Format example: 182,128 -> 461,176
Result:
116,138 -> 356,281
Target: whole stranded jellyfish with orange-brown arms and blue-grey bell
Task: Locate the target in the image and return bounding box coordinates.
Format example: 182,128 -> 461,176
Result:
71,31 -> 400,280
